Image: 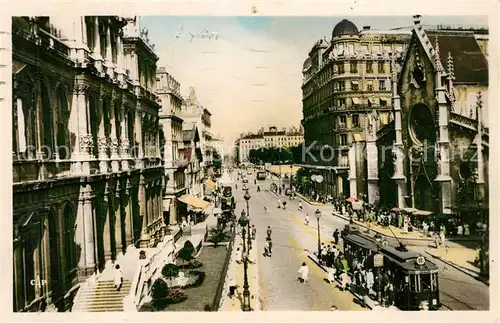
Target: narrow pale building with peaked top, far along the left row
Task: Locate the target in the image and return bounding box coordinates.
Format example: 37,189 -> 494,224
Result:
182,87 -> 214,177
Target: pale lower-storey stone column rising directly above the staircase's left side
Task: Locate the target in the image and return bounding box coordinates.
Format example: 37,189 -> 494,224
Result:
75,184 -> 96,281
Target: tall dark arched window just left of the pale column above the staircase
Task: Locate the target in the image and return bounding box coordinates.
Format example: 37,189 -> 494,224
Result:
63,205 -> 76,288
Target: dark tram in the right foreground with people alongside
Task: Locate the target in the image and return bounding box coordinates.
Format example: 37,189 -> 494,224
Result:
343,232 -> 441,311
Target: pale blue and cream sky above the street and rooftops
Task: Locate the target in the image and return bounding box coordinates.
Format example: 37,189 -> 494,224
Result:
141,16 -> 487,152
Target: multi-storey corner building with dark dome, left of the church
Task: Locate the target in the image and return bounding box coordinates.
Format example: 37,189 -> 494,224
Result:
302,19 -> 410,200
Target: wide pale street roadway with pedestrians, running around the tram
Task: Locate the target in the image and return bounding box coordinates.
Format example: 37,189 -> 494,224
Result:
235,176 -> 489,311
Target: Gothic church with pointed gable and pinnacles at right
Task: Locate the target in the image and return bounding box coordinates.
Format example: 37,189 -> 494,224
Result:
375,16 -> 489,214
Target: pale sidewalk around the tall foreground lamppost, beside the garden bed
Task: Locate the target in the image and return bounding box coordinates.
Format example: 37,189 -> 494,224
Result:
219,234 -> 260,312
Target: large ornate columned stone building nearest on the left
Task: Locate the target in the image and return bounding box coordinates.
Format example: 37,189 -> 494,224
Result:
12,13 -> 164,311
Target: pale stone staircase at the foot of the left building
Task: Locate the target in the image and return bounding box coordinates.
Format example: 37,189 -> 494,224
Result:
71,280 -> 131,312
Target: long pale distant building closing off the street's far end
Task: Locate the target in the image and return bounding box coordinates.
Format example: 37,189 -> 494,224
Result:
235,126 -> 304,163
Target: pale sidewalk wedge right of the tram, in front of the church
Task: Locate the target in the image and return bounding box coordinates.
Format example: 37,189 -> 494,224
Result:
425,247 -> 490,286
